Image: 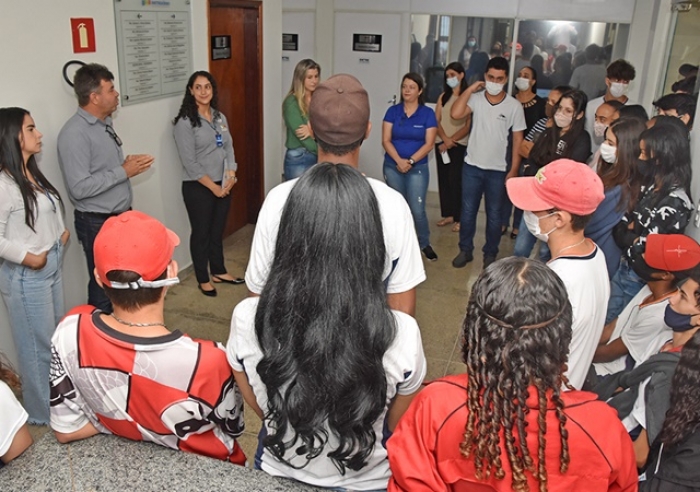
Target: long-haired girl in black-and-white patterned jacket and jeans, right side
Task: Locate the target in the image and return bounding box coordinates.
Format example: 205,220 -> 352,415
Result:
605,116 -> 693,324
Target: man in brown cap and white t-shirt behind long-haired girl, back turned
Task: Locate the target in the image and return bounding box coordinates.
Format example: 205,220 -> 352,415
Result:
245,74 -> 425,316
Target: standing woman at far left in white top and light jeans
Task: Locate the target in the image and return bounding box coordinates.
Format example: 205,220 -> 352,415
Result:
0,108 -> 69,425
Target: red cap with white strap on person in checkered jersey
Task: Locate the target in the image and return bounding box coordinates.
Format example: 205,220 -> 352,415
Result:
93,210 -> 180,289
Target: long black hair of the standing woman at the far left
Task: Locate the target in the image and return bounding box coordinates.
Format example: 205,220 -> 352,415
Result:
0,108 -> 63,232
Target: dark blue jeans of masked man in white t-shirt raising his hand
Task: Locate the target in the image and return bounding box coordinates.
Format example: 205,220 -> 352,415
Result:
459,162 -> 506,257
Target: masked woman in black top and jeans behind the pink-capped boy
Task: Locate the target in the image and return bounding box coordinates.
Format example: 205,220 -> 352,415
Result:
513,90 -> 591,257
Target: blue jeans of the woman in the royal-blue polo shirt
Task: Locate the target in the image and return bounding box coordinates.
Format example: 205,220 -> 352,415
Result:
384,159 -> 430,249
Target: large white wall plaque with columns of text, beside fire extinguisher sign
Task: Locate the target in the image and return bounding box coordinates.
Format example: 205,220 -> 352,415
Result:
114,0 -> 192,106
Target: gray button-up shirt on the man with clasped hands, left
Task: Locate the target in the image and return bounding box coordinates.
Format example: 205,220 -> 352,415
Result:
58,108 -> 132,214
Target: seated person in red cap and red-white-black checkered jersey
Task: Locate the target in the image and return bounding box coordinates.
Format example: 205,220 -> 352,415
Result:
50,211 -> 245,465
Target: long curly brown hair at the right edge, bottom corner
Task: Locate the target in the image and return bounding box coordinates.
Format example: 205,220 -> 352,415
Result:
658,332 -> 700,446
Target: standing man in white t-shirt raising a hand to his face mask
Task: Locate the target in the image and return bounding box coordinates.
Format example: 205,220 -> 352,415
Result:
450,56 -> 526,268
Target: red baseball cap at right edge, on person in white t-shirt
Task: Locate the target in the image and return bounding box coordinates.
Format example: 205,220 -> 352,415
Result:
644,234 -> 700,272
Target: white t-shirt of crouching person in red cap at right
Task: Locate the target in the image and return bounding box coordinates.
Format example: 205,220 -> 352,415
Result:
593,285 -> 673,376
